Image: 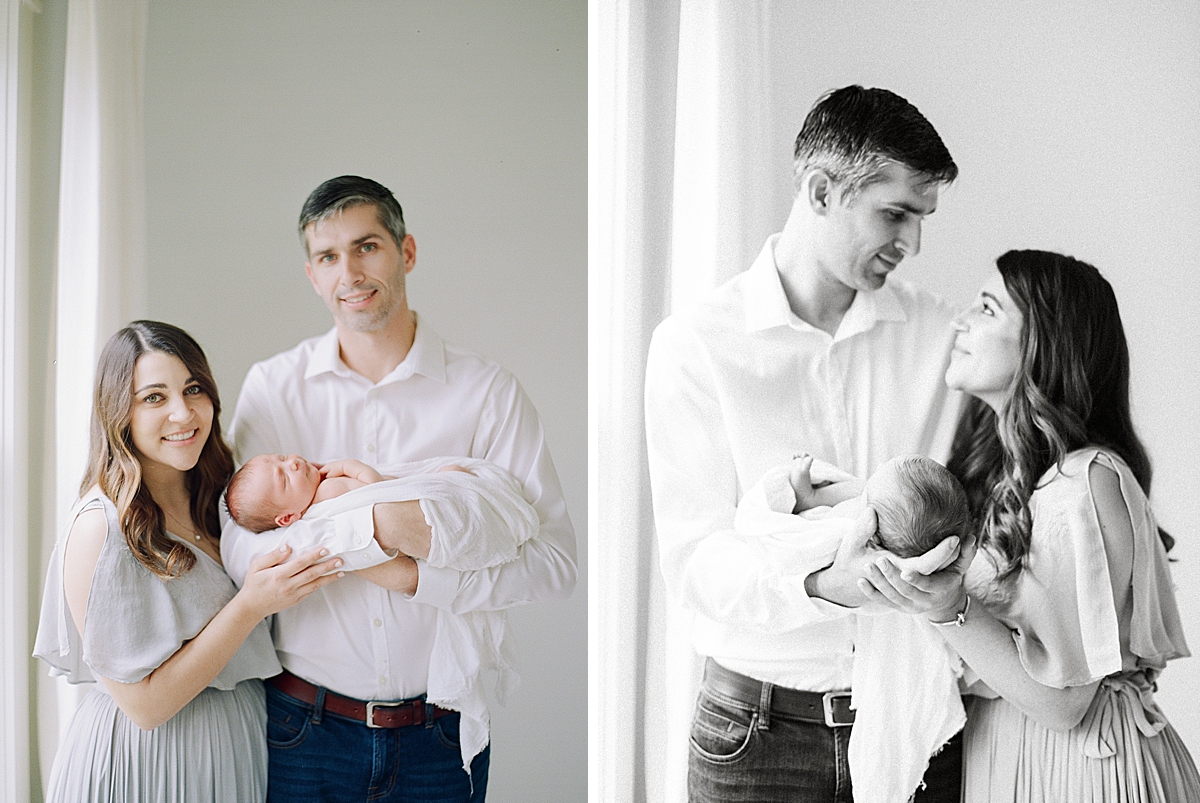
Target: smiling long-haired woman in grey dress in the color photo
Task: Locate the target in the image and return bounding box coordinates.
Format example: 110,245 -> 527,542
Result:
34,320 -> 341,803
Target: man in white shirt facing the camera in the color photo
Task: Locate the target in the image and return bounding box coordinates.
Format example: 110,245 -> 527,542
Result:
222,175 -> 576,802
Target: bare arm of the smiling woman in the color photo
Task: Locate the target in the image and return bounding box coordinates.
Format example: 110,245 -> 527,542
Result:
62,509 -> 343,731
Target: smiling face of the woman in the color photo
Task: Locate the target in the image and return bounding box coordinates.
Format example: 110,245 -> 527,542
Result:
130,352 -> 212,473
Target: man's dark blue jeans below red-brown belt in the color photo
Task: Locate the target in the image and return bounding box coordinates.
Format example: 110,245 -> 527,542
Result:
266,685 -> 491,803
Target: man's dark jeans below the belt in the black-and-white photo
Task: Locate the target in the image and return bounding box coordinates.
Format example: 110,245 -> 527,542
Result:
688,682 -> 962,803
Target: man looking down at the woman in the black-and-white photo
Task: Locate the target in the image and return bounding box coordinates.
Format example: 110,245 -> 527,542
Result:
646,86 -> 967,801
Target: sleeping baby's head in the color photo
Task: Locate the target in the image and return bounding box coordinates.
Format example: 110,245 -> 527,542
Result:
226,455 -> 320,533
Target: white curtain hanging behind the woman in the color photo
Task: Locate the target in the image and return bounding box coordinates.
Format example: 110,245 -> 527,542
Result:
41,0 -> 148,773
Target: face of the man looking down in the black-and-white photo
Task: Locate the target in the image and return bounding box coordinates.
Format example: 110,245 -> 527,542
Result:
818,162 -> 938,290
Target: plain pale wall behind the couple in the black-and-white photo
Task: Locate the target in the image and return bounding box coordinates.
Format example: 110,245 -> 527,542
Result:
762,0 -> 1200,754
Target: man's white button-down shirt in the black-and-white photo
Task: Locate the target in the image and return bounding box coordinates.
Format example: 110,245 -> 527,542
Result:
646,235 -> 960,691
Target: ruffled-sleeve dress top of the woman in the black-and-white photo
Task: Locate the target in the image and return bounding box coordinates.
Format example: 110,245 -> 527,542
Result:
996,449 -> 1189,688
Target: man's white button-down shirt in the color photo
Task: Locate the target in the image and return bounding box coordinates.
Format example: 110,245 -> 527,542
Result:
222,323 -> 576,700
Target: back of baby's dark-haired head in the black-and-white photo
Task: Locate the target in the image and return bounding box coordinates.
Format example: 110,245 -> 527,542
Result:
863,455 -> 971,558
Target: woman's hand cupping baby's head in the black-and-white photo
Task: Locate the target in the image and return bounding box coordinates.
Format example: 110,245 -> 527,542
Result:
858,535 -> 976,622
